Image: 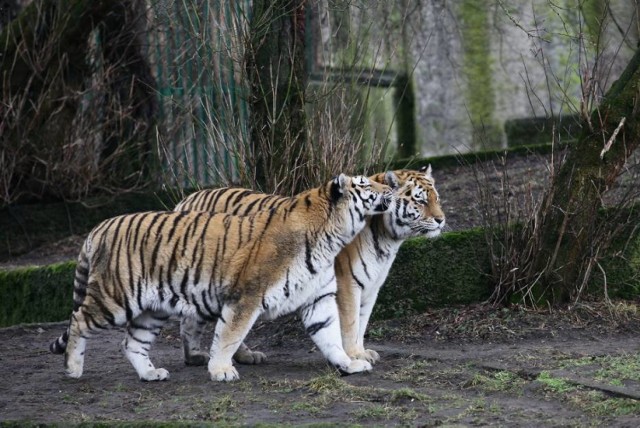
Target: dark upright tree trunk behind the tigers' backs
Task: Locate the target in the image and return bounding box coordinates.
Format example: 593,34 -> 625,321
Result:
247,0 -> 307,193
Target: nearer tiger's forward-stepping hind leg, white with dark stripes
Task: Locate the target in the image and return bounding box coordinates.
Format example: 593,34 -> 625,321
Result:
122,311 -> 169,381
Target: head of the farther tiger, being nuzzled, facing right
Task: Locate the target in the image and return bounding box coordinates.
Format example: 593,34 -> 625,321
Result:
373,165 -> 445,239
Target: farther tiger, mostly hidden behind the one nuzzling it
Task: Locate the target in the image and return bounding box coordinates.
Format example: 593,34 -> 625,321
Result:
174,165 -> 446,365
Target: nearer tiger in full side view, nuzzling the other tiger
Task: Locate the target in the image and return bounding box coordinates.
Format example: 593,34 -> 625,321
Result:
49,173 -> 393,381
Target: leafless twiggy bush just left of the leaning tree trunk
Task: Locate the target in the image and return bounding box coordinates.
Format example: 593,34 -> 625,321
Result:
470,140 -> 561,306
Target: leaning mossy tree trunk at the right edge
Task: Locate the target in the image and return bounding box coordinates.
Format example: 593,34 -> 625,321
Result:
528,45 -> 640,303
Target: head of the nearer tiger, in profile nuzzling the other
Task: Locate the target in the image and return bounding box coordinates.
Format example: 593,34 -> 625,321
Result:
330,171 -> 398,220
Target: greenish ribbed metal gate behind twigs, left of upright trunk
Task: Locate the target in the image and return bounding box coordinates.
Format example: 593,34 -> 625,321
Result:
147,0 -> 251,187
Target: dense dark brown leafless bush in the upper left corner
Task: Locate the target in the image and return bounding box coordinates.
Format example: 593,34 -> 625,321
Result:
0,2 -> 154,204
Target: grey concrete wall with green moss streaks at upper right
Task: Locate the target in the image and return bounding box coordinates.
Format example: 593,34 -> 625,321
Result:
406,0 -> 638,156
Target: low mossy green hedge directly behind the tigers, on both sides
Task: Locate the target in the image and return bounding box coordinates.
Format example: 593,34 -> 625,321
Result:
0,230 -> 489,327
